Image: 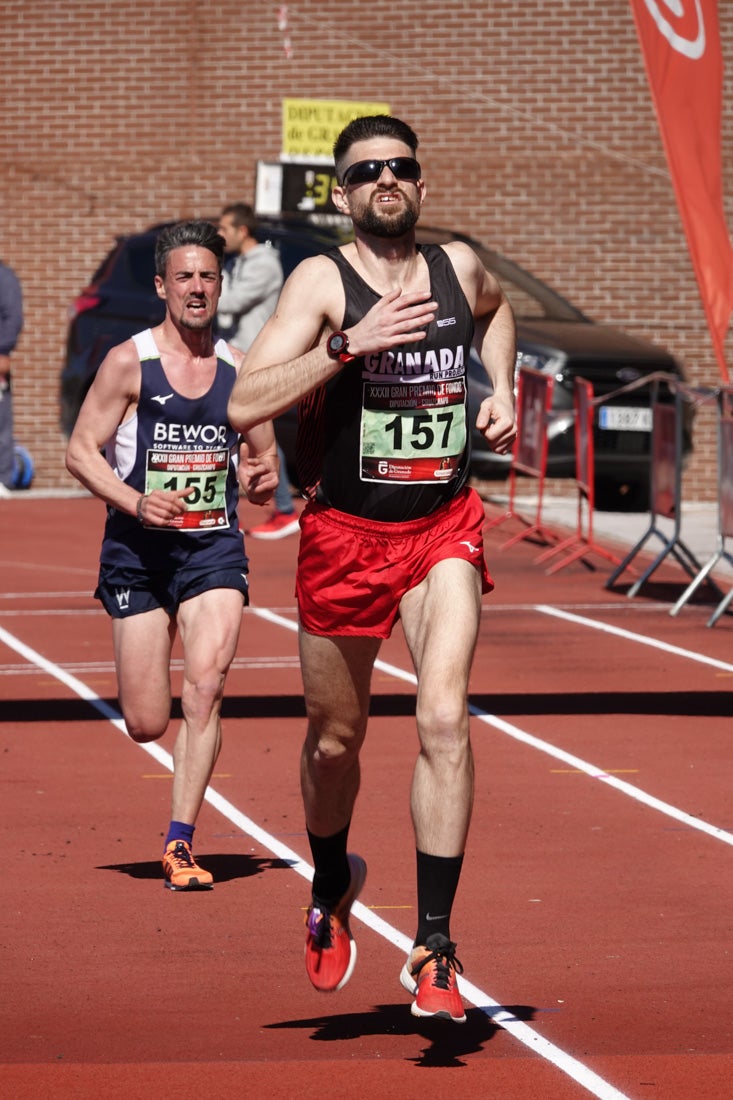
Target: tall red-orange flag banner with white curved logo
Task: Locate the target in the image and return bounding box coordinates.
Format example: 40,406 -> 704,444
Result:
631,0 -> 733,382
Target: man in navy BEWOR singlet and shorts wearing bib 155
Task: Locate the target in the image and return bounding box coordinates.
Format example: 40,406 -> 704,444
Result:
66,221 -> 277,890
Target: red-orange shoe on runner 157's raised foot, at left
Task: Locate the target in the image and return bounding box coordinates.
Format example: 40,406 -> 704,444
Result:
305,854 -> 367,993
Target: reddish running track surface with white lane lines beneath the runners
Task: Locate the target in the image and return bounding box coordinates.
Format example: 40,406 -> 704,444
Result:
0,497 -> 733,1100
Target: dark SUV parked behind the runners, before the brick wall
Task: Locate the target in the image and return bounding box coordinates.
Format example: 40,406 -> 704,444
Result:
61,219 -> 691,507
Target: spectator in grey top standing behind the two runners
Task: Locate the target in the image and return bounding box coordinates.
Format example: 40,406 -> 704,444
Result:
217,202 -> 298,539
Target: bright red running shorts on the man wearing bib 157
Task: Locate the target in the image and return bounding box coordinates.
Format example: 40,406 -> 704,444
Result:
295,488 -> 494,638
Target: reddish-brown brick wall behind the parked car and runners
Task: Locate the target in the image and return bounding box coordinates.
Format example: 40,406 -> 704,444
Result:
0,0 -> 733,498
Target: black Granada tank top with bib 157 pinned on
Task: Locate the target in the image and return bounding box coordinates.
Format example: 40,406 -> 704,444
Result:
297,244 -> 473,523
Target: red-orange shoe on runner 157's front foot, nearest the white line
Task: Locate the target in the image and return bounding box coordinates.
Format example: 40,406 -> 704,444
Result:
400,932 -> 466,1024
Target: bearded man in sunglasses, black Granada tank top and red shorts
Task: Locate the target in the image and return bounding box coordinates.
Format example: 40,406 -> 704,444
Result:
229,116 -> 516,1023
